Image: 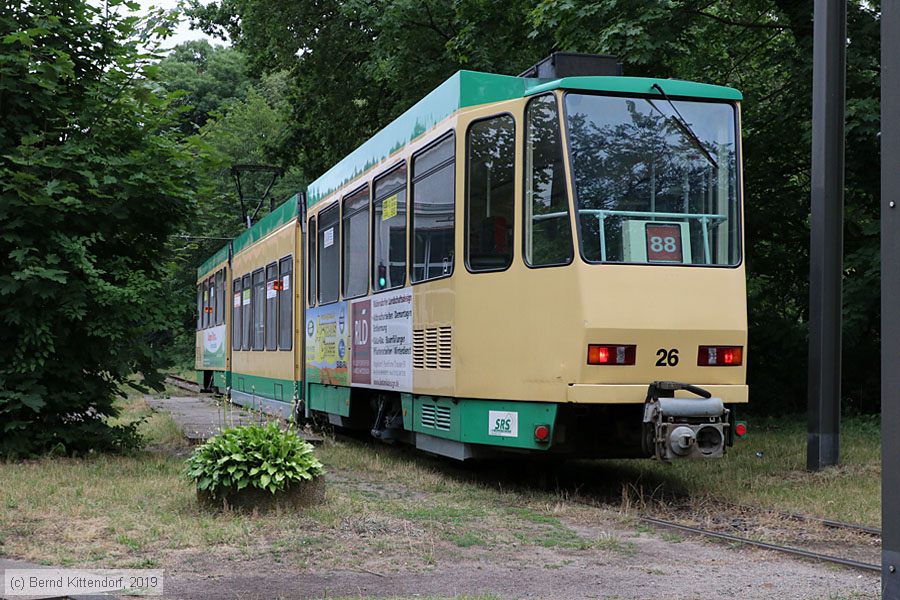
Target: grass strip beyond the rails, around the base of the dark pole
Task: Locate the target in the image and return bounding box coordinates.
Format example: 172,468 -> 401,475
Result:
595,417 -> 881,526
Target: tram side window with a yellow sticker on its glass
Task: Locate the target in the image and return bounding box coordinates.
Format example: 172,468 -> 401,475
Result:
372,163 -> 406,292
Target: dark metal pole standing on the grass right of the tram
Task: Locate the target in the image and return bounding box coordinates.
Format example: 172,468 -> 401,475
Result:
806,0 -> 847,471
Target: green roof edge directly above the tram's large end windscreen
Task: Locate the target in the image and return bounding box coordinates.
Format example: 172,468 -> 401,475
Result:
525,77 -> 743,101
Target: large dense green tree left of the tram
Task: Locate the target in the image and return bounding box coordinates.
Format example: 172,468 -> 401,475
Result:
0,0 -> 196,455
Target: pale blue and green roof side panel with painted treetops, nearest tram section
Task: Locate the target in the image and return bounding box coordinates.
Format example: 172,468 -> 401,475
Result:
306,71 -> 537,206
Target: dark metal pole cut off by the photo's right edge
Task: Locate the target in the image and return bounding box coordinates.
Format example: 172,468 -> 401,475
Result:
881,0 -> 900,600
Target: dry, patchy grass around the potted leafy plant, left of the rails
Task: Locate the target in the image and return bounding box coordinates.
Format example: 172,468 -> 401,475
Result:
0,394 -> 629,572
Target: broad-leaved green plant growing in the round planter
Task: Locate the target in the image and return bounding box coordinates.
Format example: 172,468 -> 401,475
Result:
187,423 -> 323,497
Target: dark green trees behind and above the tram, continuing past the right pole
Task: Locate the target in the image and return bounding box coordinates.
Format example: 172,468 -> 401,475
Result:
191,0 -> 880,412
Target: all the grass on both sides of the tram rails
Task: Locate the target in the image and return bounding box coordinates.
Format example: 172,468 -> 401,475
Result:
0,394 -> 880,580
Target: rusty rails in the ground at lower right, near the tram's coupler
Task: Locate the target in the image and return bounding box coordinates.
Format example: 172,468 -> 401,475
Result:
575,500 -> 881,573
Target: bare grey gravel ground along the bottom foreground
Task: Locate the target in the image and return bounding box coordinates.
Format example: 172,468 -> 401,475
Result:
158,508 -> 880,600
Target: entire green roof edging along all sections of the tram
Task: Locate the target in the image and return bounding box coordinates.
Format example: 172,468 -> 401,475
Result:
197,71 -> 743,278
